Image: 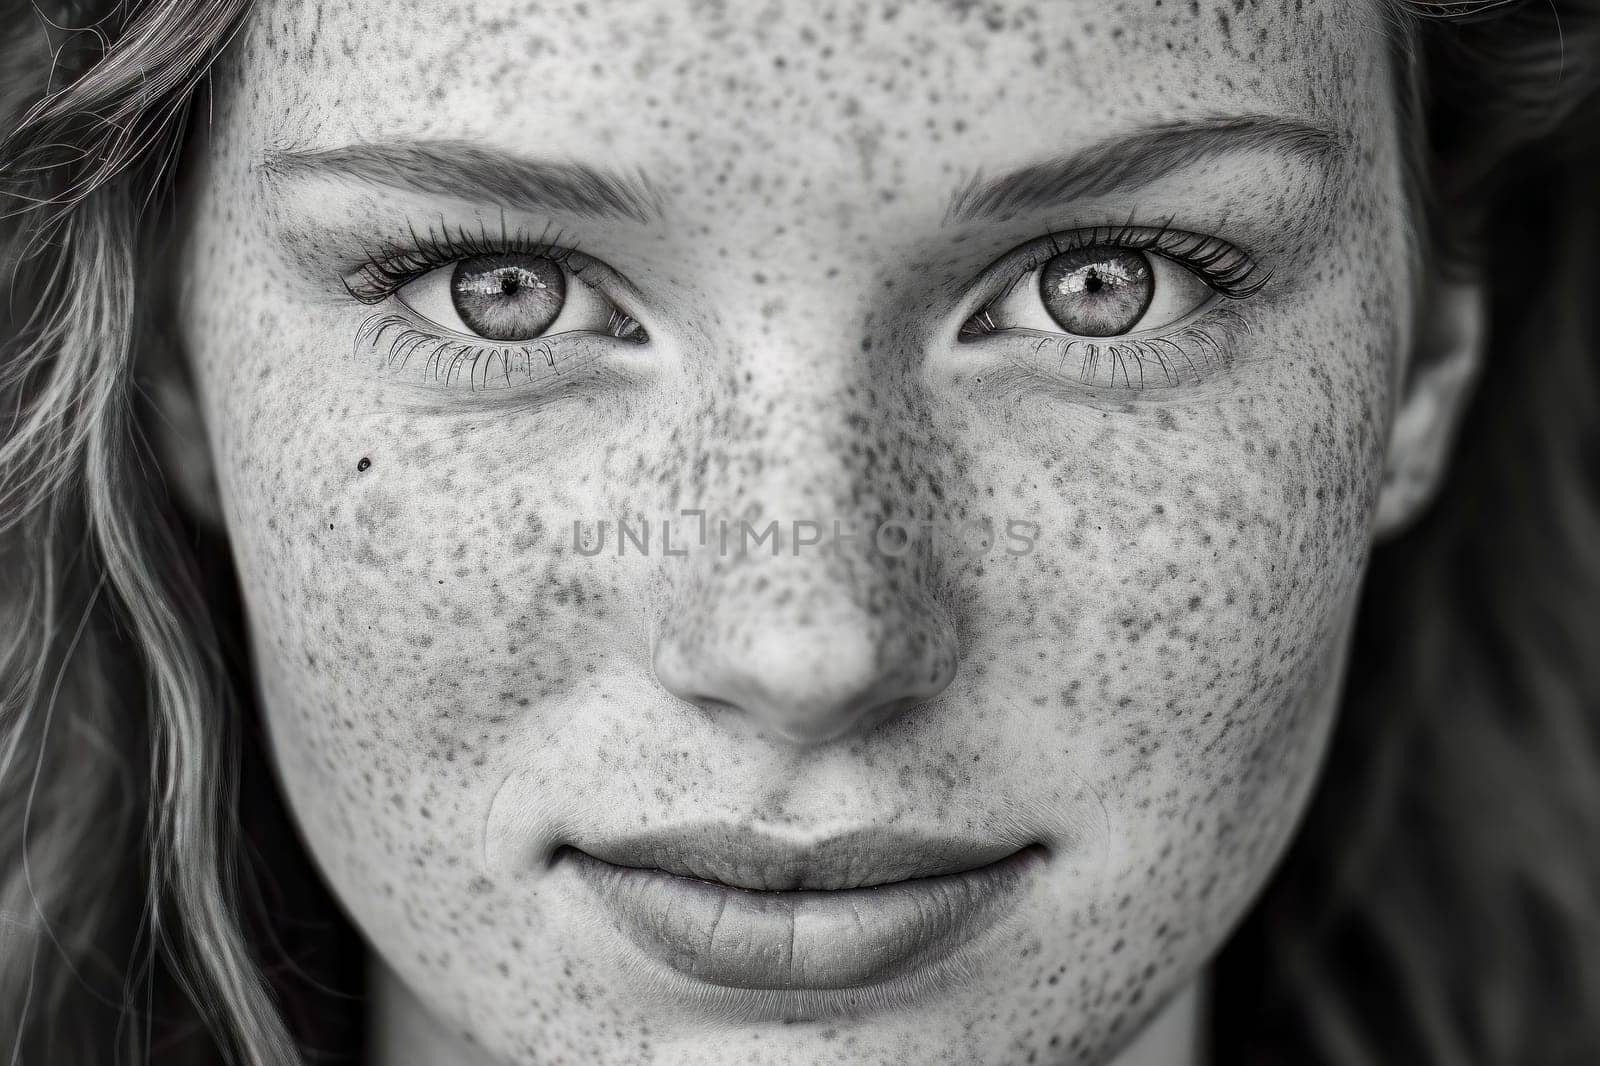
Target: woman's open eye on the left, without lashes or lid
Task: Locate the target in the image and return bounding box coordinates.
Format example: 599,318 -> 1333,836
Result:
395,253 -> 640,343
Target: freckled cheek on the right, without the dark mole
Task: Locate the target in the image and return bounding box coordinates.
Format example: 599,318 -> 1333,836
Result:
963,284 -> 1395,953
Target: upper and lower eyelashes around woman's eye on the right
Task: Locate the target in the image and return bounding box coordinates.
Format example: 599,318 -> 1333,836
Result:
960,221 -> 1272,391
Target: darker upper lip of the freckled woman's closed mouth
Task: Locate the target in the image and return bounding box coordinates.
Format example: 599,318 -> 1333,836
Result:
573,824 -> 1030,892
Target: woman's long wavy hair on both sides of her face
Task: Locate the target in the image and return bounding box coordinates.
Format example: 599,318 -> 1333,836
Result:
0,0 -> 1600,1066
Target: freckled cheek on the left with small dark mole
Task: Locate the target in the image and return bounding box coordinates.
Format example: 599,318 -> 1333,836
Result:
190,267 -> 649,902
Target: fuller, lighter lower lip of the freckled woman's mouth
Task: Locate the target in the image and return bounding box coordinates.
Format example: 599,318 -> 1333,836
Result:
563,848 -> 1043,989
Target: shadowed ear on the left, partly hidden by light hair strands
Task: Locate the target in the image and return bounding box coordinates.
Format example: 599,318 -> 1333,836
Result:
139,321 -> 222,530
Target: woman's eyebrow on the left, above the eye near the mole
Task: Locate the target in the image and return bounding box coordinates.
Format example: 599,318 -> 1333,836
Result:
259,141 -> 661,222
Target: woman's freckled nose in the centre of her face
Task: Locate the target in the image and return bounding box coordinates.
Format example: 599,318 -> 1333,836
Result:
651,249 -> 966,746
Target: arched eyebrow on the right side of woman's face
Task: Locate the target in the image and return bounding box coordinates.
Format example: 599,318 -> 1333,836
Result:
944,115 -> 1344,224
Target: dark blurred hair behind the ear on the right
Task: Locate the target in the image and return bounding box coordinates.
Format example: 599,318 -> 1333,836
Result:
1216,2 -> 1600,1066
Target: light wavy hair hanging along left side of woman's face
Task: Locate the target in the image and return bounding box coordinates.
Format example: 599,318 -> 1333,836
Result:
0,0 -> 298,1064
